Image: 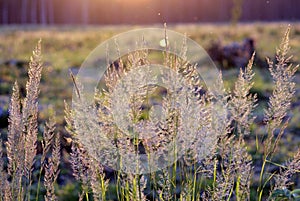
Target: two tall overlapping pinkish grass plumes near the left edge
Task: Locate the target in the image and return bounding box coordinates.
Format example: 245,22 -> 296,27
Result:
4,41 -> 47,200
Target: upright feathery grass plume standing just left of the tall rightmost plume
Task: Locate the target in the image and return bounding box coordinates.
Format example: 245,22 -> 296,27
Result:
229,54 -> 257,200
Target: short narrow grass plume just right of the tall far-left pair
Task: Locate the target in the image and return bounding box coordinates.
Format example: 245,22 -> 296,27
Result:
44,131 -> 61,201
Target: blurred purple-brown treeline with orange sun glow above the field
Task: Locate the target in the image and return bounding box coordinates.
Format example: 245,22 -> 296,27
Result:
0,0 -> 300,25
